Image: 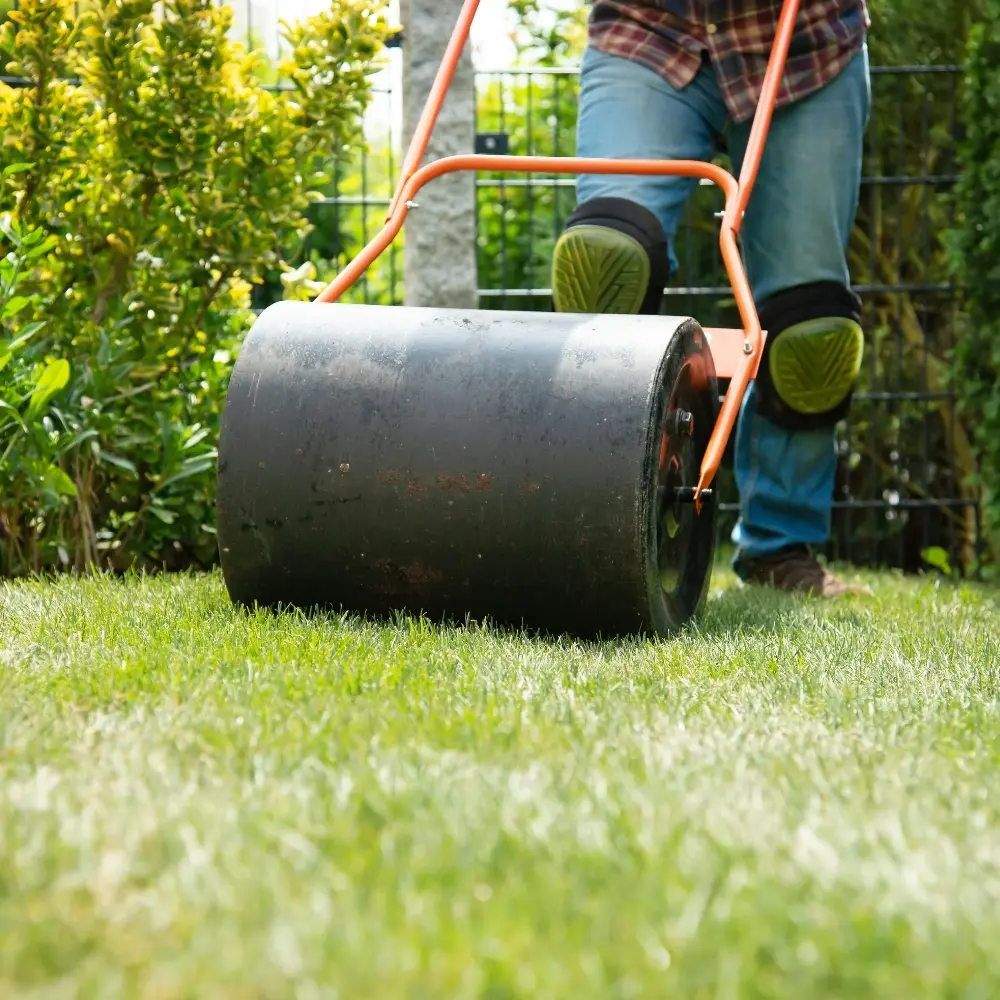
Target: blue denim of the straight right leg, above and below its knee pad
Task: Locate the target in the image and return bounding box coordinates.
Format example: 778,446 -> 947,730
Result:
727,51 -> 870,573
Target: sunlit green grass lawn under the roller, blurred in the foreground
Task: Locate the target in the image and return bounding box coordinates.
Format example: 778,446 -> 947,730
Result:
0,571 -> 1000,1000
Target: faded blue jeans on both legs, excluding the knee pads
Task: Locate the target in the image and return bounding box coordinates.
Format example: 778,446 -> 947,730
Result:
577,48 -> 871,573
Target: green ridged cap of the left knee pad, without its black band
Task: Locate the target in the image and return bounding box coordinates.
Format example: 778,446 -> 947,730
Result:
552,226 -> 649,313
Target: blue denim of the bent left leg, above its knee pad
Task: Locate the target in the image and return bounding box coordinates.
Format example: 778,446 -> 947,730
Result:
577,48 -> 726,268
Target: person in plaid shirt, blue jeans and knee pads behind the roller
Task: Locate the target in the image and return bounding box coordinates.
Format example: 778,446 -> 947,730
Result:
552,0 -> 871,597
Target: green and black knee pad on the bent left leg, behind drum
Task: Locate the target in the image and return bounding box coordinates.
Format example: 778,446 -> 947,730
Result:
552,198 -> 670,314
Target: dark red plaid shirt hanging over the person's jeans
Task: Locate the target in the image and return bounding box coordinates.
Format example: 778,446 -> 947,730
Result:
588,0 -> 870,122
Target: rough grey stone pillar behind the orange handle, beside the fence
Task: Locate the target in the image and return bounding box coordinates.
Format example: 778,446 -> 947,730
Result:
400,0 -> 478,309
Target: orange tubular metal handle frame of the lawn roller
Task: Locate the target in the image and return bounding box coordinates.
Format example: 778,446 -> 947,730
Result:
315,0 -> 799,511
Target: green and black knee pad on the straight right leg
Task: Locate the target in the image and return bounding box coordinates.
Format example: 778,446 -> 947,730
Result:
756,281 -> 864,430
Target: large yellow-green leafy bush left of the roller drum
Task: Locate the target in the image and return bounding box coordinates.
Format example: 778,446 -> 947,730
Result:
0,0 -> 385,575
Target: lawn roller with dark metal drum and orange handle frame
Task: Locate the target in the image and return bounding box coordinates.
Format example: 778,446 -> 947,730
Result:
217,0 -> 798,636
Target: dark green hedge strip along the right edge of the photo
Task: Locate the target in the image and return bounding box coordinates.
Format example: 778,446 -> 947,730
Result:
950,0 -> 1000,572
